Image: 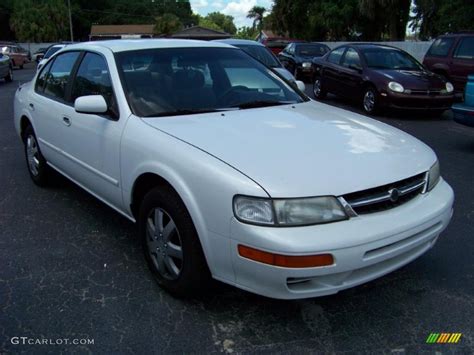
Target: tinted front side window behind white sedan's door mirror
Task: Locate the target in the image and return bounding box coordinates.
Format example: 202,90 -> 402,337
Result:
71,53 -> 114,107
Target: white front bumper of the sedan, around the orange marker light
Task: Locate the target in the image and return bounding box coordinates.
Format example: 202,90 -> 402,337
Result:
231,180 -> 454,299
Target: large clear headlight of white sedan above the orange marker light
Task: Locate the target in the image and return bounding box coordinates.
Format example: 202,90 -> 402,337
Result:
234,196 -> 348,226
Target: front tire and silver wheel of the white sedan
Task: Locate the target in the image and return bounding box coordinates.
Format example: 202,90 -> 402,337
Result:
138,187 -> 211,297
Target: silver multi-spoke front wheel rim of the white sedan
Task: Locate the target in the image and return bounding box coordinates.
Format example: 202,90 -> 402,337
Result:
146,207 -> 183,280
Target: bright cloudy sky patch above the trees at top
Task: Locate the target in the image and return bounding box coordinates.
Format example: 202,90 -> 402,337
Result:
190,0 -> 273,27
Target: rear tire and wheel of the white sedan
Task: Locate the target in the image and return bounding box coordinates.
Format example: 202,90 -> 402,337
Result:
23,126 -> 51,186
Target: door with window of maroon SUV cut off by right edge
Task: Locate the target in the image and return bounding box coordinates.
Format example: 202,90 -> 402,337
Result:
451,36 -> 474,91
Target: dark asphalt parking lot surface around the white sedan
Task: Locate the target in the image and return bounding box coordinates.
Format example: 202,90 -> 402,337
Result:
0,65 -> 474,353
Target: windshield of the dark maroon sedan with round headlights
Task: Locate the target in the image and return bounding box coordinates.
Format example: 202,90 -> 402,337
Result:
362,48 -> 423,70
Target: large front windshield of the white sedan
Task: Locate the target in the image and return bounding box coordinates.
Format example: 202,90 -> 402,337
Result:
116,48 -> 306,117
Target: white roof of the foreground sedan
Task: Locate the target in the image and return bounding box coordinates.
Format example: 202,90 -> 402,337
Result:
68,38 -> 232,52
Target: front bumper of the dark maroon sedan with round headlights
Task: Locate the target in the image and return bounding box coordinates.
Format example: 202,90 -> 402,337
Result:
380,92 -> 454,110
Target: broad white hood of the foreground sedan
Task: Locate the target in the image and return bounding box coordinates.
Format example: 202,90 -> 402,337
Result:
143,101 -> 436,197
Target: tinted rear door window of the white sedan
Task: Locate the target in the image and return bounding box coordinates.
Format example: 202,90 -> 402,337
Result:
44,52 -> 79,101
